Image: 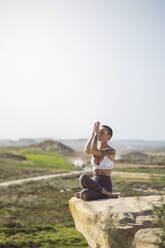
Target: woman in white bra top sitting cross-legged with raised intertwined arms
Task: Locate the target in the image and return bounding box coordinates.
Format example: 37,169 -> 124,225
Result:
75,121 -> 120,201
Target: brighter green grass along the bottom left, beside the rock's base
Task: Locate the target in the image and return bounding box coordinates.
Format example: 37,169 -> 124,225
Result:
0,223 -> 87,248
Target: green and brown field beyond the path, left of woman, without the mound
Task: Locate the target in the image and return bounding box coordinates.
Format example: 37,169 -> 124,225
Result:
0,147 -> 79,182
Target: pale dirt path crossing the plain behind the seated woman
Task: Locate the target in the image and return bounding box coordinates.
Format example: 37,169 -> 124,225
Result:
0,168 -> 165,186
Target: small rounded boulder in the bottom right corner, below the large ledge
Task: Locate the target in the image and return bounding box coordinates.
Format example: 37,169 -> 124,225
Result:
133,228 -> 162,248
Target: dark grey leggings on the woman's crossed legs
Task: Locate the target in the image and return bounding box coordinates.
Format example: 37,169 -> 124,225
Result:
79,174 -> 112,201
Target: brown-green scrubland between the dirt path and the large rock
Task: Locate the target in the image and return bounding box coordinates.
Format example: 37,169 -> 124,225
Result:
0,173 -> 164,248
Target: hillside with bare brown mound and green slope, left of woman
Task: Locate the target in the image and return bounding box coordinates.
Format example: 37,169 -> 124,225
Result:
0,140 -> 75,182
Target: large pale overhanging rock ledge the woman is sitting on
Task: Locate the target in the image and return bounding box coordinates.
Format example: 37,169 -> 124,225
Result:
69,196 -> 165,248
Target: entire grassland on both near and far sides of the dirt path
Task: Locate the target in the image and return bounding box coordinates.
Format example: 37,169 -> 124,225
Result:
0,147 -> 165,248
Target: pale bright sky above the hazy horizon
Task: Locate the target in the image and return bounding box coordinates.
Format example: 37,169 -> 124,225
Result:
0,0 -> 165,140
